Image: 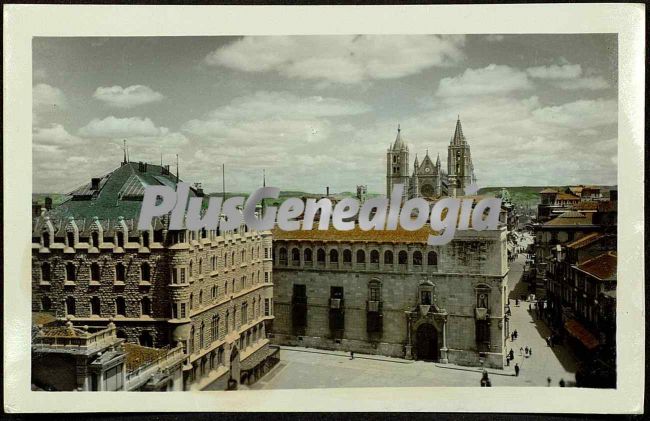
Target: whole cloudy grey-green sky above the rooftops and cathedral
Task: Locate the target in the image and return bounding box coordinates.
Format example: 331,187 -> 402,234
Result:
32,34 -> 618,193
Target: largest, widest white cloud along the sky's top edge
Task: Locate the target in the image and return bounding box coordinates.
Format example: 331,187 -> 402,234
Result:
205,35 -> 464,84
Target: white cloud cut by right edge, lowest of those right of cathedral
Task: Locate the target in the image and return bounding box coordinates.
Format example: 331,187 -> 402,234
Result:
533,99 -> 618,130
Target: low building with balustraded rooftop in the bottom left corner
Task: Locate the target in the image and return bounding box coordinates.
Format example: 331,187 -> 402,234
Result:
32,321 -> 185,392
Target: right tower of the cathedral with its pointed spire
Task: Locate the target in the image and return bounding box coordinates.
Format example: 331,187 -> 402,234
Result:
447,116 -> 475,196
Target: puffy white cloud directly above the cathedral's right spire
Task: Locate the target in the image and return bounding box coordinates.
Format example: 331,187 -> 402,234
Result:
436,64 -> 532,97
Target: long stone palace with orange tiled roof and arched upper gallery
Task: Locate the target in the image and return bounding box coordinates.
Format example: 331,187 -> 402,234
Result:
272,223 -> 508,367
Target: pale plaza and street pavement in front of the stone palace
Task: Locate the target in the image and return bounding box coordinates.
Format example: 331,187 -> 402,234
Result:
250,233 -> 576,389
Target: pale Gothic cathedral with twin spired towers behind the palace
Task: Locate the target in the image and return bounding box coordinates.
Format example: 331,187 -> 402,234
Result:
386,117 -> 476,200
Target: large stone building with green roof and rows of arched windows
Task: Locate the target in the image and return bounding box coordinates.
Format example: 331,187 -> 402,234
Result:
32,159 -> 276,389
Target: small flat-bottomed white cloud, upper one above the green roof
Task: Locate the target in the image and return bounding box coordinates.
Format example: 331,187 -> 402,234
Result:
79,116 -> 169,138
